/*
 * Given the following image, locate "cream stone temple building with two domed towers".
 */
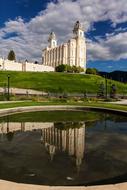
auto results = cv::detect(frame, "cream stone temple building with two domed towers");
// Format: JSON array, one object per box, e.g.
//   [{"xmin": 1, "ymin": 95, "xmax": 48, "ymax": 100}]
[{"xmin": 42, "ymin": 21, "xmax": 86, "ymax": 70}]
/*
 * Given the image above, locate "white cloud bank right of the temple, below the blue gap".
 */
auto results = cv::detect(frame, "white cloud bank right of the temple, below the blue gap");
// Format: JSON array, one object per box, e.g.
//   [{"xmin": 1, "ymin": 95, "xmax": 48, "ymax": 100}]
[{"xmin": 87, "ymin": 32, "xmax": 127, "ymax": 60}]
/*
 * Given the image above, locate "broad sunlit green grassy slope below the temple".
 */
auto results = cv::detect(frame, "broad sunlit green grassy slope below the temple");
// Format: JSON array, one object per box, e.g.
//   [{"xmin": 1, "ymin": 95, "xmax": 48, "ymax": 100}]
[{"xmin": 0, "ymin": 71, "xmax": 127, "ymax": 94}]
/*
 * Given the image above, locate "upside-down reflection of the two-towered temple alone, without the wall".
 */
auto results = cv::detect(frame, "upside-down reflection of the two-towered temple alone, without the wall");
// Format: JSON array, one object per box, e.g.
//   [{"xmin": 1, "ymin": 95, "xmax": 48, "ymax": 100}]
[{"xmin": 41, "ymin": 122, "xmax": 85, "ymax": 169}]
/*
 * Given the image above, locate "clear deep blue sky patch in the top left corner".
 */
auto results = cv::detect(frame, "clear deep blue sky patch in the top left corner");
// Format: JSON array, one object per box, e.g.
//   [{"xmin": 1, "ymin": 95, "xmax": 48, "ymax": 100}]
[{"xmin": 0, "ymin": 0, "xmax": 50, "ymax": 26}]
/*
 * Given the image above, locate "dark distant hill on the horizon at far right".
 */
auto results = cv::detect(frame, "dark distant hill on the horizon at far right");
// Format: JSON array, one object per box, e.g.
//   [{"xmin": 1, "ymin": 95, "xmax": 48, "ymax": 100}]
[{"xmin": 99, "ymin": 71, "xmax": 127, "ymax": 82}]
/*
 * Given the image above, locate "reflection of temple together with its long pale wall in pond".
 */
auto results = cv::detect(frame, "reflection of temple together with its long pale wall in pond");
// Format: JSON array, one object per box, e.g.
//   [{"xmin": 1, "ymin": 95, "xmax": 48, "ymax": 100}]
[{"xmin": 0, "ymin": 121, "xmax": 85, "ymax": 170}]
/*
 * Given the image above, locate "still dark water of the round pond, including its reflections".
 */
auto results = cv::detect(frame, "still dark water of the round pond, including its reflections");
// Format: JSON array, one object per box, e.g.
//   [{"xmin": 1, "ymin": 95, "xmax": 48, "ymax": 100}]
[{"xmin": 0, "ymin": 111, "xmax": 127, "ymax": 185}]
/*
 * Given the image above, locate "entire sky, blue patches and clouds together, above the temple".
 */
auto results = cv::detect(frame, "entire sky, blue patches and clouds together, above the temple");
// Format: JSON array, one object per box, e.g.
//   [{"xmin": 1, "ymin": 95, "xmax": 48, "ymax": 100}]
[{"xmin": 0, "ymin": 0, "xmax": 127, "ymax": 71}]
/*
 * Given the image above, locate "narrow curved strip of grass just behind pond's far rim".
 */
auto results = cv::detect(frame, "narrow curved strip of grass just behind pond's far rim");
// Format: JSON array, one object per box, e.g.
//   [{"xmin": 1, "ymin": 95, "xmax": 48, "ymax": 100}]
[{"xmin": 0, "ymin": 101, "xmax": 127, "ymax": 111}]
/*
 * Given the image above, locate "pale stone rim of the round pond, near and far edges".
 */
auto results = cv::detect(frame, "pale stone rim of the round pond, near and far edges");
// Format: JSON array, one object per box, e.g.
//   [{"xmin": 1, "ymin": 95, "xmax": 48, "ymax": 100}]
[{"xmin": 0, "ymin": 105, "xmax": 127, "ymax": 190}]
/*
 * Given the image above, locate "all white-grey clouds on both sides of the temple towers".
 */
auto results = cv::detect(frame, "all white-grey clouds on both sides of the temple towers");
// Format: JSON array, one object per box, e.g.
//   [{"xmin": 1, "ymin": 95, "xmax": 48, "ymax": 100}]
[{"xmin": 0, "ymin": 0, "xmax": 127, "ymax": 61}]
